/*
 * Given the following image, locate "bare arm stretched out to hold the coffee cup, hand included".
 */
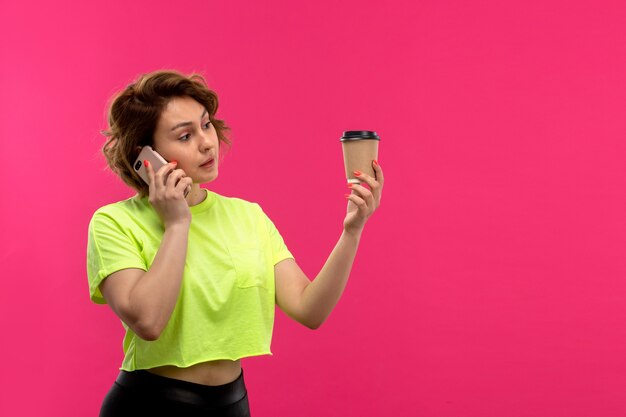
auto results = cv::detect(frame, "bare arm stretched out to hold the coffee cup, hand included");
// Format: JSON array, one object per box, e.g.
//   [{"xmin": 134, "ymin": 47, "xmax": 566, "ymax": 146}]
[{"xmin": 274, "ymin": 161, "xmax": 385, "ymax": 329}]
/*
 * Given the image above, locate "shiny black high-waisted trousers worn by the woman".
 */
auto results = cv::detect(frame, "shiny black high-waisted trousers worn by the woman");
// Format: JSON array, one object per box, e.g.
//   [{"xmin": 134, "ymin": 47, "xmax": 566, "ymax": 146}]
[{"xmin": 100, "ymin": 370, "xmax": 250, "ymax": 417}]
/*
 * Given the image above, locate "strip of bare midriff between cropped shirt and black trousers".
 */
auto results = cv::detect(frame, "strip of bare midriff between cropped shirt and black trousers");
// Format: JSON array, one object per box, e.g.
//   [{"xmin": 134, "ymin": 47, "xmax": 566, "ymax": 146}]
[{"xmin": 148, "ymin": 360, "xmax": 241, "ymax": 386}]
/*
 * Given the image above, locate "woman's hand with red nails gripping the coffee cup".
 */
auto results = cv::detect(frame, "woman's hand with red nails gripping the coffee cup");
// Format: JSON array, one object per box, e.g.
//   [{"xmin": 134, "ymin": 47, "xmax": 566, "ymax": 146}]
[{"xmin": 343, "ymin": 161, "xmax": 385, "ymax": 234}]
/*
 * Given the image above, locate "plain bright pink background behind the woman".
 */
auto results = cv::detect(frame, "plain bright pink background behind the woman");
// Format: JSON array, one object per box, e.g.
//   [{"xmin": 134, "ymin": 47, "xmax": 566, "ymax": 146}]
[{"xmin": 0, "ymin": 0, "xmax": 626, "ymax": 417}]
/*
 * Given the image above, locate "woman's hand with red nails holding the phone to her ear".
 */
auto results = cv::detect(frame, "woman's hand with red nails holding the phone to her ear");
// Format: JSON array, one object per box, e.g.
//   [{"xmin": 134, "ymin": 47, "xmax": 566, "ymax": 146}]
[{"xmin": 144, "ymin": 161, "xmax": 193, "ymax": 229}]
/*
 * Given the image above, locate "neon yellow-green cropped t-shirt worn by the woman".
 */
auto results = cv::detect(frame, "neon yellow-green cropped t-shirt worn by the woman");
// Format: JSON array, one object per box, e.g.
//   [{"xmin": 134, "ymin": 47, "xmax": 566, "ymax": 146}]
[{"xmin": 87, "ymin": 190, "xmax": 293, "ymax": 371}]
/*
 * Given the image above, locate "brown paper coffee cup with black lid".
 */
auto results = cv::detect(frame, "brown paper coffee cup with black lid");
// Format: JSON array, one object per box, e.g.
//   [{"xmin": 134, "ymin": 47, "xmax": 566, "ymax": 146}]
[{"xmin": 340, "ymin": 130, "xmax": 380, "ymax": 184}]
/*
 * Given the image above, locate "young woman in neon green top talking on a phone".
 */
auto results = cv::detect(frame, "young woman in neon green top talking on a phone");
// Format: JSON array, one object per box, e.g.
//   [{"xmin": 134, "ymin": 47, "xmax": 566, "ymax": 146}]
[{"xmin": 87, "ymin": 71, "xmax": 383, "ymax": 417}]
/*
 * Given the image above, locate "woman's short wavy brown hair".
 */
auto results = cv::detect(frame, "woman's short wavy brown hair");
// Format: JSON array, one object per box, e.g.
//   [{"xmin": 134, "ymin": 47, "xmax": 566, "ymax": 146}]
[{"xmin": 102, "ymin": 71, "xmax": 230, "ymax": 196}]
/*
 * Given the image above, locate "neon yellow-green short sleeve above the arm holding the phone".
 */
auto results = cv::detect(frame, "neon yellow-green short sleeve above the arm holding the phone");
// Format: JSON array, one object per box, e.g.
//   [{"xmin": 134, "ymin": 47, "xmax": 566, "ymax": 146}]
[{"xmin": 87, "ymin": 212, "xmax": 147, "ymax": 304}]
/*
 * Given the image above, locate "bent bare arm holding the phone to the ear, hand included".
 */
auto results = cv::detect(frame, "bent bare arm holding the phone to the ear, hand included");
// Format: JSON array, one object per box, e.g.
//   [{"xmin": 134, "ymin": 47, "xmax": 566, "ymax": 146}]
[{"xmin": 100, "ymin": 163, "xmax": 192, "ymax": 340}]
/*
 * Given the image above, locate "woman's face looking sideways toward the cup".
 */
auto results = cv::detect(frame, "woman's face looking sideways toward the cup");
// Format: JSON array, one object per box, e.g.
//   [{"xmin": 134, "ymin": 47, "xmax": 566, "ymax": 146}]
[{"xmin": 153, "ymin": 97, "xmax": 219, "ymax": 183}]
